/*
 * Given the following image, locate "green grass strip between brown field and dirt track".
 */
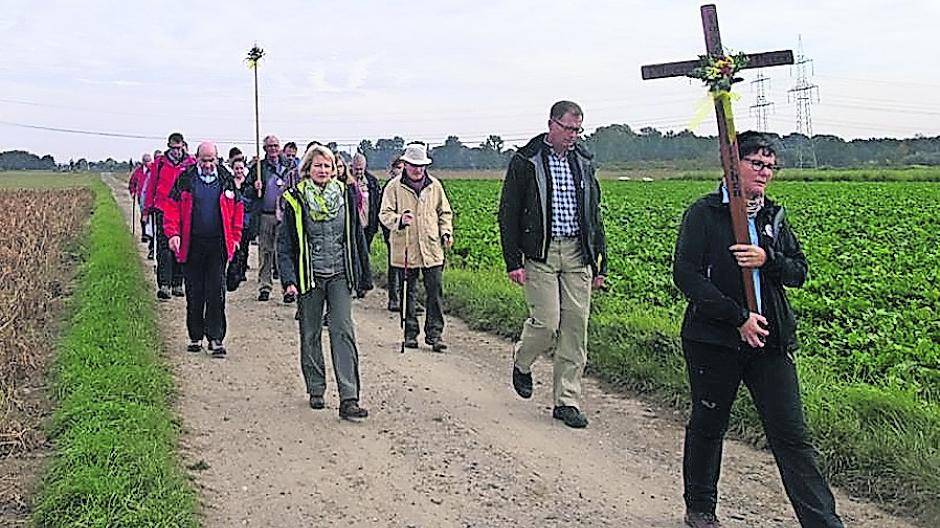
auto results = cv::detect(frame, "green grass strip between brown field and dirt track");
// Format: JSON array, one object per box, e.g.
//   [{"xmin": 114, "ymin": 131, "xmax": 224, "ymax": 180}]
[{"xmin": 32, "ymin": 181, "xmax": 197, "ymax": 527}]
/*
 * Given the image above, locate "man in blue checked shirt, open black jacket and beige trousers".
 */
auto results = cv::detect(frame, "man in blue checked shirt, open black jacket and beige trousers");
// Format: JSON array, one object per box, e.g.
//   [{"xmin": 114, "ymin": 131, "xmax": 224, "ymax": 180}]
[{"xmin": 499, "ymin": 101, "xmax": 607, "ymax": 428}]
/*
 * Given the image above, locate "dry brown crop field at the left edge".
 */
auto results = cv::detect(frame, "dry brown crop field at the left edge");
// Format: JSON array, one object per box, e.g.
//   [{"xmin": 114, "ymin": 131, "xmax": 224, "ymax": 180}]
[{"xmin": 0, "ymin": 189, "xmax": 93, "ymax": 524}]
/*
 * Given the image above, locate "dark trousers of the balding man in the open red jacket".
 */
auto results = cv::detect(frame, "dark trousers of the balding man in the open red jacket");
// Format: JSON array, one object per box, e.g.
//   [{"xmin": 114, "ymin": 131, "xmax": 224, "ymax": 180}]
[{"xmin": 185, "ymin": 237, "xmax": 226, "ymax": 341}]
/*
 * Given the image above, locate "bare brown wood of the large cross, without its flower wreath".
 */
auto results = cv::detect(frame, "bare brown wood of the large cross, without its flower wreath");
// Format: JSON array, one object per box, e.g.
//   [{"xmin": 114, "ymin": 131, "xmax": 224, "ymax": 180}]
[{"xmin": 640, "ymin": 4, "xmax": 793, "ymax": 312}]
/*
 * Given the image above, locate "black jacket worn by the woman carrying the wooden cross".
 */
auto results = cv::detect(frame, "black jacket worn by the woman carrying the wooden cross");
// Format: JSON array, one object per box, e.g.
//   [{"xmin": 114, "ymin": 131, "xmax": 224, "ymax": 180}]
[{"xmin": 673, "ymin": 191, "xmax": 808, "ymax": 352}]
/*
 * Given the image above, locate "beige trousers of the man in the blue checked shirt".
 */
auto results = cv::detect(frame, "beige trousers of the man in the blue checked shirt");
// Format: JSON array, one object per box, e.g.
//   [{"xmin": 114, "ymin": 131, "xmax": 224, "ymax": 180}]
[{"xmin": 515, "ymin": 238, "xmax": 592, "ymax": 408}]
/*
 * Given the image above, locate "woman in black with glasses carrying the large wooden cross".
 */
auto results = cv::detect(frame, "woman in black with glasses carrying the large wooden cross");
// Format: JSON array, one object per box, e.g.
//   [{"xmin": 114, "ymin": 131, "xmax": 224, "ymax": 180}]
[{"xmin": 673, "ymin": 132, "xmax": 842, "ymax": 528}]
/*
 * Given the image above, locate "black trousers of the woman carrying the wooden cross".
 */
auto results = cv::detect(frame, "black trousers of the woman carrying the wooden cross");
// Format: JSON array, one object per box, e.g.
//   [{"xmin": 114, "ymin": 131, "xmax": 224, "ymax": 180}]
[{"xmin": 682, "ymin": 339, "xmax": 843, "ymax": 528}]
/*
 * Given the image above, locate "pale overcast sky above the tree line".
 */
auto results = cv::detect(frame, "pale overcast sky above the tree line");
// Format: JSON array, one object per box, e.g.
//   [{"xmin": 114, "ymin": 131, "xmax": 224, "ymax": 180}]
[{"xmin": 0, "ymin": 0, "xmax": 940, "ymax": 162}]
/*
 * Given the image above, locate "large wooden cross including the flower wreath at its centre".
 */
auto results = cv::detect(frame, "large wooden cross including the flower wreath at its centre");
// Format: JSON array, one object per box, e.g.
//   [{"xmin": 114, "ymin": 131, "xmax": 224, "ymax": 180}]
[{"xmin": 641, "ymin": 4, "xmax": 793, "ymax": 312}]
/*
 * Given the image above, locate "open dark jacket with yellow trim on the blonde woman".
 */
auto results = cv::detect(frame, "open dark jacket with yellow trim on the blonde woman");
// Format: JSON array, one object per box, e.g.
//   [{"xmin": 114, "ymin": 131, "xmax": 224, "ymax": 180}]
[{"xmin": 277, "ymin": 185, "xmax": 372, "ymax": 294}]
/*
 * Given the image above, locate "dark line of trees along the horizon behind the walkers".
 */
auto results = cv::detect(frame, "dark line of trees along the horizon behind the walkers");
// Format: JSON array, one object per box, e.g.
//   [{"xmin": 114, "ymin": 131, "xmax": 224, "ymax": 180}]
[{"xmin": 7, "ymin": 125, "xmax": 940, "ymax": 172}]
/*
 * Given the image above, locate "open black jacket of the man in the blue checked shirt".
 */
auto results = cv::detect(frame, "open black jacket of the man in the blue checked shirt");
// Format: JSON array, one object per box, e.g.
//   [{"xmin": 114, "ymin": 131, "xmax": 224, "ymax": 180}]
[{"xmin": 499, "ymin": 134, "xmax": 607, "ymax": 276}]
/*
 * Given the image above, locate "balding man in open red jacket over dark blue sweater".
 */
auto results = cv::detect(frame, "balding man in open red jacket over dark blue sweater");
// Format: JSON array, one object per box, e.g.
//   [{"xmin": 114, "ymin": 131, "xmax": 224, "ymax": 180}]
[{"xmin": 163, "ymin": 142, "xmax": 245, "ymax": 357}]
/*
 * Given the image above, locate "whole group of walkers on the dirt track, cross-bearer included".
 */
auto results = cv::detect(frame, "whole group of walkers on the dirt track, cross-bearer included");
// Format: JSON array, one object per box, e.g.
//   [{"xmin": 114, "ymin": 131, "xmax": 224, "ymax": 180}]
[{"xmin": 129, "ymin": 101, "xmax": 842, "ymax": 528}]
